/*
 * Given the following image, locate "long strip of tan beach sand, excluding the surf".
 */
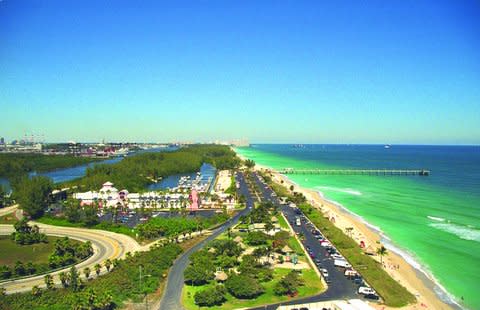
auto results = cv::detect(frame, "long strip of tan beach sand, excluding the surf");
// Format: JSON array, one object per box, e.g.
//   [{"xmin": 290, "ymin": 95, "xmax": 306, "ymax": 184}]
[{"xmin": 234, "ymin": 150, "xmax": 454, "ymax": 309}]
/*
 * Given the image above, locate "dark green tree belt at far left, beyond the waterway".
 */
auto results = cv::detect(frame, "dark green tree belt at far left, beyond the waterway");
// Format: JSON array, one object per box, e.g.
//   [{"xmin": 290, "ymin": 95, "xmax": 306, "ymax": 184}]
[{"xmin": 0, "ymin": 153, "xmax": 99, "ymax": 179}]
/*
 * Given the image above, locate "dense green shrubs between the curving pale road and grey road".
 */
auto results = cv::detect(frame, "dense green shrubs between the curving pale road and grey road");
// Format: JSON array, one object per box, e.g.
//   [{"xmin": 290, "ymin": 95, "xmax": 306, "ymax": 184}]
[{"xmin": 0, "ymin": 244, "xmax": 182, "ymax": 310}]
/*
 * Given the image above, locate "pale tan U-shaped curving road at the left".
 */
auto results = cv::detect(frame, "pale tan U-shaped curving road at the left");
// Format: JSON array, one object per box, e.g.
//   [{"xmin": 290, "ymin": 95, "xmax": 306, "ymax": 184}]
[{"xmin": 0, "ymin": 223, "xmax": 142, "ymax": 293}]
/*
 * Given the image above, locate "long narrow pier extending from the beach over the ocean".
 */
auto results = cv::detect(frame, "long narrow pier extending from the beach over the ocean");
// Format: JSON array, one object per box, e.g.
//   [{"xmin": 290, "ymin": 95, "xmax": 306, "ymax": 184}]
[{"xmin": 278, "ymin": 168, "xmax": 430, "ymax": 176}]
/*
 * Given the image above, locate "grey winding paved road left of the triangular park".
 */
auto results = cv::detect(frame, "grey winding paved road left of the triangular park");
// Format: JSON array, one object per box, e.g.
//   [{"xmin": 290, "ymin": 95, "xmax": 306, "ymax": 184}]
[{"xmin": 160, "ymin": 172, "xmax": 254, "ymax": 310}]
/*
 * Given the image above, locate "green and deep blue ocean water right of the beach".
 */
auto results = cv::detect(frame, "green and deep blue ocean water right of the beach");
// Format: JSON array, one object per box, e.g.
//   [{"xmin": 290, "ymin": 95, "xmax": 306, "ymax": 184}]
[{"xmin": 236, "ymin": 144, "xmax": 480, "ymax": 309}]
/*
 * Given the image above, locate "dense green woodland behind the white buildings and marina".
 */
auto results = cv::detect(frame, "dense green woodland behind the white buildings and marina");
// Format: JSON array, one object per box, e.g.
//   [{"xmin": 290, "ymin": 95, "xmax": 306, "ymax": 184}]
[{"xmin": 67, "ymin": 145, "xmax": 240, "ymax": 192}]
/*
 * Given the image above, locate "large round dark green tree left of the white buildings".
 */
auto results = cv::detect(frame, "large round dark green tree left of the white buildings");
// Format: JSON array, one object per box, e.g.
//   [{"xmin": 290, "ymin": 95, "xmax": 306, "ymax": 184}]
[{"xmin": 13, "ymin": 176, "xmax": 53, "ymax": 218}]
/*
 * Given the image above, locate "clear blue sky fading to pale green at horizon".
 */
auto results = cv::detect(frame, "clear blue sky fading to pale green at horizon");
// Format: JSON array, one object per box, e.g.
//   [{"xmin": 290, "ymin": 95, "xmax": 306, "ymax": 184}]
[{"xmin": 0, "ymin": 0, "xmax": 480, "ymax": 144}]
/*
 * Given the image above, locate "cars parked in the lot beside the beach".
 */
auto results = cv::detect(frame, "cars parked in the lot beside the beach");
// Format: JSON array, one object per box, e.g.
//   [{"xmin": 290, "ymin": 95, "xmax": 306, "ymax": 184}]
[{"xmin": 297, "ymin": 211, "xmax": 379, "ymax": 300}]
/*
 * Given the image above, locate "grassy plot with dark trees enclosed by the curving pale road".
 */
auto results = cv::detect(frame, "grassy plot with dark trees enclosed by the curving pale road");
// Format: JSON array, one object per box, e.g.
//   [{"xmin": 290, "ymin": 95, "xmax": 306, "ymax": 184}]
[{"xmin": 0, "ymin": 236, "xmax": 86, "ymax": 280}]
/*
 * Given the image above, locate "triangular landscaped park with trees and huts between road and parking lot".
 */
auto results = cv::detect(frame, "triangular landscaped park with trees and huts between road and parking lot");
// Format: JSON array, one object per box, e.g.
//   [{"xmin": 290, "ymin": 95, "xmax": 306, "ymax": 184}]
[{"xmin": 182, "ymin": 203, "xmax": 325, "ymax": 310}]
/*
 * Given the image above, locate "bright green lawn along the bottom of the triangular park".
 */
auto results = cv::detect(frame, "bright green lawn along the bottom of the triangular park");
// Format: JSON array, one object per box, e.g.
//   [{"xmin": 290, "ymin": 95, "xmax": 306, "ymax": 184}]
[{"xmin": 182, "ymin": 268, "xmax": 324, "ymax": 310}]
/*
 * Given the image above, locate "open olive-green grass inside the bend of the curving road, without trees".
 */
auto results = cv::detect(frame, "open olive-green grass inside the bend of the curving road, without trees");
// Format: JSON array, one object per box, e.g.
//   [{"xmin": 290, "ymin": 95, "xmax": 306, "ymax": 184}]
[{"xmin": 0, "ymin": 236, "xmax": 80, "ymax": 267}]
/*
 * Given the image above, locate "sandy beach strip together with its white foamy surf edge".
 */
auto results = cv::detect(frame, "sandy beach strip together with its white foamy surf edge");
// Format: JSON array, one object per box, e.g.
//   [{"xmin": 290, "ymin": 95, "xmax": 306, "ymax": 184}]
[{"xmin": 237, "ymin": 153, "xmax": 462, "ymax": 309}]
